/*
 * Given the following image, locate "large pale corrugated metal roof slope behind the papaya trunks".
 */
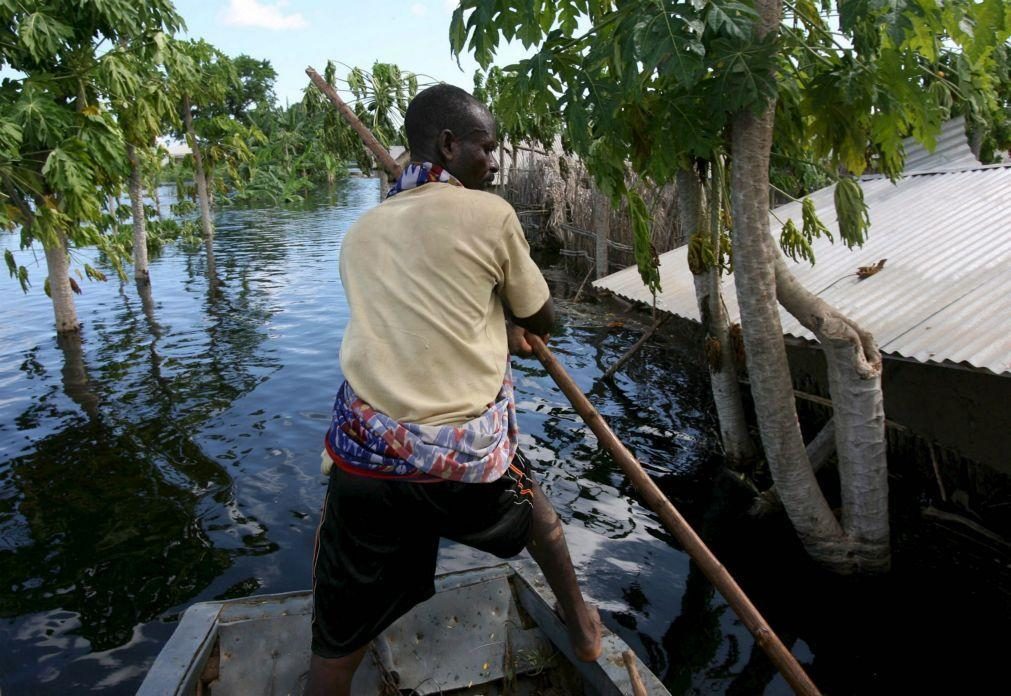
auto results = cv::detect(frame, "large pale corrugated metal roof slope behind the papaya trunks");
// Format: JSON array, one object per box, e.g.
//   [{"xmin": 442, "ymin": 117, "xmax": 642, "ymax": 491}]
[{"xmin": 593, "ymin": 164, "xmax": 1011, "ymax": 374}]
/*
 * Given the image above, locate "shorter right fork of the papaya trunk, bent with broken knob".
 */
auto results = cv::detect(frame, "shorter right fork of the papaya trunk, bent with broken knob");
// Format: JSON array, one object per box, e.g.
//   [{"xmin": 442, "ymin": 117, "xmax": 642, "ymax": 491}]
[{"xmin": 775, "ymin": 253, "xmax": 891, "ymax": 572}]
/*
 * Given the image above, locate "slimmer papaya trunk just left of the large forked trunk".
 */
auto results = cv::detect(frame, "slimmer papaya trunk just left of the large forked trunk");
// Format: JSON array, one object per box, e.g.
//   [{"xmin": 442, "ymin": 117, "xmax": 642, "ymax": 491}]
[{"xmin": 676, "ymin": 169, "xmax": 755, "ymax": 466}]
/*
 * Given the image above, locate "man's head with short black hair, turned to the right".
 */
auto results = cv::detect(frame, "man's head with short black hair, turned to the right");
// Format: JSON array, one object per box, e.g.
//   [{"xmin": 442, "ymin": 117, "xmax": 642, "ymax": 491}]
[{"xmin": 403, "ymin": 85, "xmax": 498, "ymax": 189}]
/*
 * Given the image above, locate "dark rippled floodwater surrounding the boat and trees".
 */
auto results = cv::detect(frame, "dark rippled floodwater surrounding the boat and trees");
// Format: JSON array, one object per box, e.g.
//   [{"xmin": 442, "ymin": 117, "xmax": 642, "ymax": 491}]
[{"xmin": 0, "ymin": 179, "xmax": 1011, "ymax": 696}]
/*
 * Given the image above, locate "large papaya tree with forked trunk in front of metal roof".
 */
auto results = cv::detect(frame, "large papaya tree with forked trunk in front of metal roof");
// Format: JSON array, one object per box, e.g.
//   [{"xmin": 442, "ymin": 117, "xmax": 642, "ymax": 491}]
[{"xmin": 450, "ymin": 0, "xmax": 1011, "ymax": 573}]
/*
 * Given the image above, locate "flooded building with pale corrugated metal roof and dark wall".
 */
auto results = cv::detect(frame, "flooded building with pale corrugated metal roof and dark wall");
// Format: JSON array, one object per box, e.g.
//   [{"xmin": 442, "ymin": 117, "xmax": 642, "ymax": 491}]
[{"xmin": 594, "ymin": 119, "xmax": 1011, "ymax": 534}]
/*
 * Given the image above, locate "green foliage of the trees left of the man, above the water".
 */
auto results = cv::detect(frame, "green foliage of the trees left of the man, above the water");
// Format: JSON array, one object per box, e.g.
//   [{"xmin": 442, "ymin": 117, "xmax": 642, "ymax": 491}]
[{"xmin": 0, "ymin": 0, "xmax": 382, "ymax": 309}]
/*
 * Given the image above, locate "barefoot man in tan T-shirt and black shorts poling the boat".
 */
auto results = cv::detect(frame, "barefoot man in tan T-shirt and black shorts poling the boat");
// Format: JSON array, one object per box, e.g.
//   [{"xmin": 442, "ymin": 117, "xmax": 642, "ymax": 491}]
[{"xmin": 308, "ymin": 85, "xmax": 601, "ymax": 695}]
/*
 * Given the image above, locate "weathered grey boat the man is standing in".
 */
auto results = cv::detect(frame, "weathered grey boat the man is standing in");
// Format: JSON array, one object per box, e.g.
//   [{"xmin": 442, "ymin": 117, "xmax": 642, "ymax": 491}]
[{"xmin": 137, "ymin": 560, "xmax": 669, "ymax": 696}]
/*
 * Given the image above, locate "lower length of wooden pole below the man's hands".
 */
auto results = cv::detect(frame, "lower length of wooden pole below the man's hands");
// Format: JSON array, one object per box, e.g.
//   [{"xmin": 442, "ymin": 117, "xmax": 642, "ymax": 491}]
[{"xmin": 529, "ymin": 336, "xmax": 819, "ymax": 696}]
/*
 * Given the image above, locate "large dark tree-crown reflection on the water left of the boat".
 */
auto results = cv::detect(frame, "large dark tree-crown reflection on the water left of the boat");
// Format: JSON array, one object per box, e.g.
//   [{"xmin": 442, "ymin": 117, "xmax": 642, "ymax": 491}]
[{"xmin": 0, "ymin": 325, "xmax": 228, "ymax": 649}]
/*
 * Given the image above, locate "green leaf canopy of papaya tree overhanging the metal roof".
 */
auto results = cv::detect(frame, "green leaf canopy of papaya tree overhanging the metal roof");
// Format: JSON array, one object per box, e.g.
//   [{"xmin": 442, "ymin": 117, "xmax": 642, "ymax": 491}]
[{"xmin": 449, "ymin": 0, "xmax": 1011, "ymax": 285}]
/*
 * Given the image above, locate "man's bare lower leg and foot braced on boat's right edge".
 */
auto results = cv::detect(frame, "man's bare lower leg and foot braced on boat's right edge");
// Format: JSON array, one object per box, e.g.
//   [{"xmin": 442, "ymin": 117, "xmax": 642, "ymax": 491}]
[{"xmin": 527, "ymin": 484, "xmax": 601, "ymax": 662}]
